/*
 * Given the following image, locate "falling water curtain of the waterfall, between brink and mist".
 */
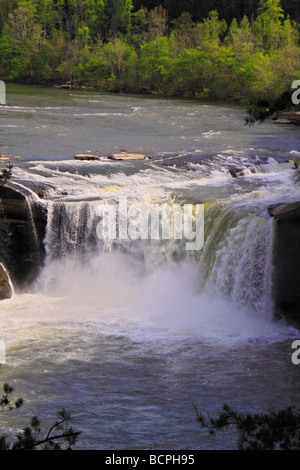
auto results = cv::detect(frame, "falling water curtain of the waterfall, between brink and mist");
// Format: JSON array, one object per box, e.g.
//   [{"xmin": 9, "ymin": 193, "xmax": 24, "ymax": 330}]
[{"xmin": 45, "ymin": 195, "xmax": 273, "ymax": 319}]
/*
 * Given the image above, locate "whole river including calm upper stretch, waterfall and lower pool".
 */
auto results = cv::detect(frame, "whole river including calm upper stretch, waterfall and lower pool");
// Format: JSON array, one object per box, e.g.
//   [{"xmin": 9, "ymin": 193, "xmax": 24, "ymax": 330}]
[{"xmin": 0, "ymin": 84, "xmax": 300, "ymax": 450}]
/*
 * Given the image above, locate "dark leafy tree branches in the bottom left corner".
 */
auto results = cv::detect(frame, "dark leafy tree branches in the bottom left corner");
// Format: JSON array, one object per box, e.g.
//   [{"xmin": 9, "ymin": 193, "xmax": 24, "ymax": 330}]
[{"xmin": 0, "ymin": 383, "xmax": 80, "ymax": 450}]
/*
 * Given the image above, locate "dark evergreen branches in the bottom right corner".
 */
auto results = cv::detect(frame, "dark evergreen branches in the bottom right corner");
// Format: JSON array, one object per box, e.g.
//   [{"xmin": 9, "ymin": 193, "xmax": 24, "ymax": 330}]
[{"xmin": 195, "ymin": 404, "xmax": 300, "ymax": 450}]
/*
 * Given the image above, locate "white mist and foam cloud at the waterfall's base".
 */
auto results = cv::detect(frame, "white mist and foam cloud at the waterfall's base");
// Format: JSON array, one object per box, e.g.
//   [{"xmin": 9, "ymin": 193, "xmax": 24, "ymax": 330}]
[{"xmin": 1, "ymin": 254, "xmax": 296, "ymax": 356}]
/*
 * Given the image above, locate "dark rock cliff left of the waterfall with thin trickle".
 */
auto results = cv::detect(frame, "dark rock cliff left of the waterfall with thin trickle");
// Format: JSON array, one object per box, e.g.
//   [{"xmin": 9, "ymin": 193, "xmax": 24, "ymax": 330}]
[{"xmin": 0, "ymin": 184, "xmax": 47, "ymax": 288}]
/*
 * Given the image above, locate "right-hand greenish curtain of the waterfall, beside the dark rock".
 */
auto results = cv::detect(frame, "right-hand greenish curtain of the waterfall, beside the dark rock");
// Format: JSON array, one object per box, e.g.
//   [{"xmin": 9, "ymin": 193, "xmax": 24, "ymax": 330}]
[{"xmin": 201, "ymin": 204, "xmax": 274, "ymax": 319}]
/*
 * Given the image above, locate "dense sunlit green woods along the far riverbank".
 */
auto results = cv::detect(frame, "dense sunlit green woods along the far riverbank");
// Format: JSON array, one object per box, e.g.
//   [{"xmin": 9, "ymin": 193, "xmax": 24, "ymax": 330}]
[{"xmin": 0, "ymin": 0, "xmax": 300, "ymax": 106}]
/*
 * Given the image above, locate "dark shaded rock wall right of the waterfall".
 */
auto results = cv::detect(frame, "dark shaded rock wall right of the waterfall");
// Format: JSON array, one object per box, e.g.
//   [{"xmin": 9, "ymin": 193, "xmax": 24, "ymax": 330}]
[{"xmin": 269, "ymin": 202, "xmax": 300, "ymax": 327}]
